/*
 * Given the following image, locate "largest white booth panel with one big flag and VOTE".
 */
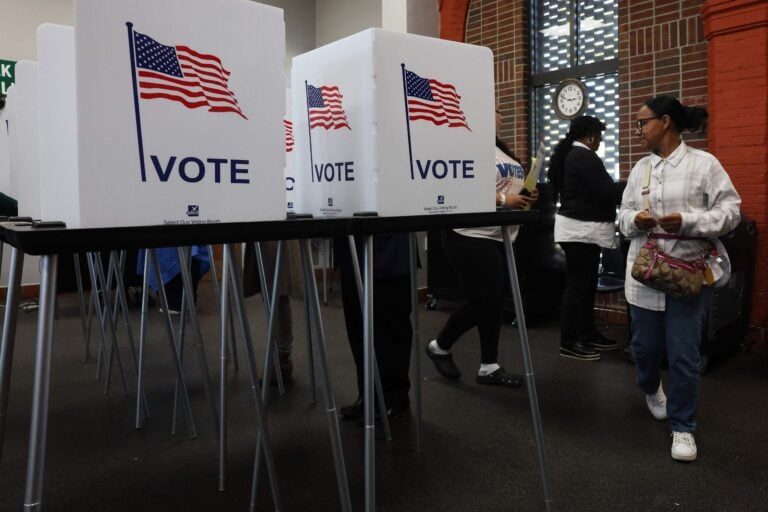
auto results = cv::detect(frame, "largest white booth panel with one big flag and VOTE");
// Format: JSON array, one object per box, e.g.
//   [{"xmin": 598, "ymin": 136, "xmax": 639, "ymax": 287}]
[{"xmin": 75, "ymin": 0, "xmax": 286, "ymax": 227}]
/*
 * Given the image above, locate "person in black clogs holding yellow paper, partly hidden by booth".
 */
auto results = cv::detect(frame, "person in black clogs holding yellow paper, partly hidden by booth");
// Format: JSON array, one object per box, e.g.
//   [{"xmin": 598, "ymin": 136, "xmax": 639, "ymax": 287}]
[{"xmin": 427, "ymin": 108, "xmax": 539, "ymax": 387}]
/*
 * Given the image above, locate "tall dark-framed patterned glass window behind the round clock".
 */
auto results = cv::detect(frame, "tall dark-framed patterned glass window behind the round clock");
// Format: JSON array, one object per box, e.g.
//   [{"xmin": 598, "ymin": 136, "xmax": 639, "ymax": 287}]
[{"xmin": 530, "ymin": 0, "xmax": 619, "ymax": 179}]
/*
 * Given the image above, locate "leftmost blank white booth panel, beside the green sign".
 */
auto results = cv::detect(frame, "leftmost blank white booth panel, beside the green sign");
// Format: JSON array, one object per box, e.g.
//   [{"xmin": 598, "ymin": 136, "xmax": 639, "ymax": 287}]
[{"xmin": 8, "ymin": 60, "xmax": 41, "ymax": 219}]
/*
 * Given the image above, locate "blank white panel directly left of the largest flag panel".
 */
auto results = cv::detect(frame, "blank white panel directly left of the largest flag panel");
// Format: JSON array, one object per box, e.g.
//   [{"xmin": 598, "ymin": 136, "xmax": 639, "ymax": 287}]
[{"xmin": 37, "ymin": 23, "xmax": 80, "ymax": 226}]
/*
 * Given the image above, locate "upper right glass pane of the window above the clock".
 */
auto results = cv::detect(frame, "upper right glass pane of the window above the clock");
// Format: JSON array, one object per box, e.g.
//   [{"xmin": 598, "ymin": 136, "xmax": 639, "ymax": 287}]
[{"xmin": 576, "ymin": 0, "xmax": 619, "ymax": 65}]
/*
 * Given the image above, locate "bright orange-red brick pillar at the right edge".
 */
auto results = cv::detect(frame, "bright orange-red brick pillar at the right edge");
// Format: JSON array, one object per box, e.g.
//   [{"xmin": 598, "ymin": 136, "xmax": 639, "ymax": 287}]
[{"xmin": 704, "ymin": 0, "xmax": 768, "ymax": 328}]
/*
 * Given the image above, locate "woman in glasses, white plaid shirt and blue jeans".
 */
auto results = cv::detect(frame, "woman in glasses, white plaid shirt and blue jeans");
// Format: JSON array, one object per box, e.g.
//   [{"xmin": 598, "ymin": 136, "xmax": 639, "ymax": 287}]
[{"xmin": 619, "ymin": 96, "xmax": 741, "ymax": 461}]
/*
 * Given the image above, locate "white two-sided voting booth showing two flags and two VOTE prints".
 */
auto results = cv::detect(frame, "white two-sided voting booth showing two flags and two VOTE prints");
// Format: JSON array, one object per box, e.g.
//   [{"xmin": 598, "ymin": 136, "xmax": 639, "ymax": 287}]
[{"xmin": 291, "ymin": 29, "xmax": 496, "ymax": 216}]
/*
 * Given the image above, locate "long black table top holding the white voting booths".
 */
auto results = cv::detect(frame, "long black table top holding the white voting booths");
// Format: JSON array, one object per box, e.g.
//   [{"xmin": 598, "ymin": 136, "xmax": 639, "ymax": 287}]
[{"xmin": 0, "ymin": 210, "xmax": 538, "ymax": 255}]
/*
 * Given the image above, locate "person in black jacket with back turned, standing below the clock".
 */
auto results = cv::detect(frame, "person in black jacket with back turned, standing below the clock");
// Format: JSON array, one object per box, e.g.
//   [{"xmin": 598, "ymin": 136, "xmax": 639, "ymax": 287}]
[{"xmin": 547, "ymin": 116, "xmax": 619, "ymax": 361}]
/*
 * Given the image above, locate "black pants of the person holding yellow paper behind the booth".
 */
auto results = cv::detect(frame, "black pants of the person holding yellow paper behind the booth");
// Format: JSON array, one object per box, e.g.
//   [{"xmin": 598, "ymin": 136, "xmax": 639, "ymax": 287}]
[{"xmin": 437, "ymin": 230, "xmax": 507, "ymax": 364}]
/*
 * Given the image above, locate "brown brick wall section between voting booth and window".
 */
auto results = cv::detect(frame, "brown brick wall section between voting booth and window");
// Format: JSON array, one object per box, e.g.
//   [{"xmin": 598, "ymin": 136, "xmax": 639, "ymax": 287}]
[{"xmin": 465, "ymin": 0, "xmax": 529, "ymax": 164}]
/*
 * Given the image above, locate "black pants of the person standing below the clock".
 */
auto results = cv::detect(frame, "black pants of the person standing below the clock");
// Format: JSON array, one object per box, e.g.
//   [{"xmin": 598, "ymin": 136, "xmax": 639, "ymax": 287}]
[{"xmin": 560, "ymin": 242, "xmax": 600, "ymax": 345}]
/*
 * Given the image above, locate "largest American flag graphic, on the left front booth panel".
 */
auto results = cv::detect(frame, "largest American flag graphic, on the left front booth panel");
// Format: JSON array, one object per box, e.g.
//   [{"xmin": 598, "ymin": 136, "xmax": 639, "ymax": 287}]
[{"xmin": 133, "ymin": 31, "xmax": 248, "ymax": 119}]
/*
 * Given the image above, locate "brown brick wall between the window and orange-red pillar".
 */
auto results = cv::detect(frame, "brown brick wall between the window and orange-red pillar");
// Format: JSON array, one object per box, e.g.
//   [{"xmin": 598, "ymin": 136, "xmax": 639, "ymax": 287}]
[{"xmin": 619, "ymin": 0, "xmax": 707, "ymax": 178}]
